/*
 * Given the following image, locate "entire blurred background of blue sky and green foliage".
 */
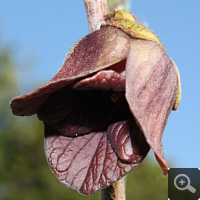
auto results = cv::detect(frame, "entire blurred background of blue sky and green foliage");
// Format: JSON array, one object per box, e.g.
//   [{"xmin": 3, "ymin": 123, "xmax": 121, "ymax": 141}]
[{"xmin": 0, "ymin": 0, "xmax": 200, "ymax": 200}]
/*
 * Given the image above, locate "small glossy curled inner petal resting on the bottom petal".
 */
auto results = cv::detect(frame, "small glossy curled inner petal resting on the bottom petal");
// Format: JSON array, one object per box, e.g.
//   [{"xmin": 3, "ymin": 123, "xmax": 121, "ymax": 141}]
[{"xmin": 107, "ymin": 120, "xmax": 149, "ymax": 163}]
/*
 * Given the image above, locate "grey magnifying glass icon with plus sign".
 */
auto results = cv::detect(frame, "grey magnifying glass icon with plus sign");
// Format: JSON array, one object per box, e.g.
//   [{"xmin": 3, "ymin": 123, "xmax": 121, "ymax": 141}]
[{"xmin": 174, "ymin": 174, "xmax": 196, "ymax": 193}]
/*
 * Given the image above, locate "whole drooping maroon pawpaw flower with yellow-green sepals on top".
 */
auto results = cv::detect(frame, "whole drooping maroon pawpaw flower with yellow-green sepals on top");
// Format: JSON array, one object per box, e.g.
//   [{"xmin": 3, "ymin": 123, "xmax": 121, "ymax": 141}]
[{"xmin": 11, "ymin": 11, "xmax": 180, "ymax": 195}]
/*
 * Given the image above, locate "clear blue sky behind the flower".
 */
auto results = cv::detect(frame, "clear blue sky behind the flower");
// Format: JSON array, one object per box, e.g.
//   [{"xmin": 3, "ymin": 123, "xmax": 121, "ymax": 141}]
[{"xmin": 0, "ymin": 0, "xmax": 200, "ymax": 168}]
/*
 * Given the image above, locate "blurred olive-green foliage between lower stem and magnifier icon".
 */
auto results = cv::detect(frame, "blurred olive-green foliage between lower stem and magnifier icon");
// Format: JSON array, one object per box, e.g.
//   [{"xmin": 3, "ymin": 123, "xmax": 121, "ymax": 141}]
[{"xmin": 126, "ymin": 158, "xmax": 168, "ymax": 200}]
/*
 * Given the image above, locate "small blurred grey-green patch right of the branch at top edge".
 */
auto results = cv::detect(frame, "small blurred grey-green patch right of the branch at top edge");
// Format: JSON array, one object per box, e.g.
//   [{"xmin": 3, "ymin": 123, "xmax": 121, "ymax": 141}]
[{"xmin": 107, "ymin": 0, "xmax": 131, "ymax": 11}]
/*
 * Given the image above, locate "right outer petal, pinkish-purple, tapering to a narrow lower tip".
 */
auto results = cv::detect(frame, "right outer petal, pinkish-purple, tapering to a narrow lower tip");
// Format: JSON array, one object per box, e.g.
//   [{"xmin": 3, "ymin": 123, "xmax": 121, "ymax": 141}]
[{"xmin": 126, "ymin": 40, "xmax": 178, "ymax": 174}]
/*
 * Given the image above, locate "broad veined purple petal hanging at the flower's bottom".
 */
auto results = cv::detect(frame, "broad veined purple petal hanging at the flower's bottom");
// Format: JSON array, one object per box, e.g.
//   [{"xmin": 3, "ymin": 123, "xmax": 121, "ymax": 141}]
[{"xmin": 45, "ymin": 126, "xmax": 147, "ymax": 195}]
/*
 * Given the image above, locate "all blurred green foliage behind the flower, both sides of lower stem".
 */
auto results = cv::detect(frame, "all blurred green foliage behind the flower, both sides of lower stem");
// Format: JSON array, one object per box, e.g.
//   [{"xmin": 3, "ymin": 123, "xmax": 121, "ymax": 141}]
[{"xmin": 0, "ymin": 35, "xmax": 167, "ymax": 200}]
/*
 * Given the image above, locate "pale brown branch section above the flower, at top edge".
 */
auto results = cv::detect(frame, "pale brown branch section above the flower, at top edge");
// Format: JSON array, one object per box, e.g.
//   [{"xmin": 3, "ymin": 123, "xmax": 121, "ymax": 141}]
[{"xmin": 84, "ymin": 0, "xmax": 109, "ymax": 33}]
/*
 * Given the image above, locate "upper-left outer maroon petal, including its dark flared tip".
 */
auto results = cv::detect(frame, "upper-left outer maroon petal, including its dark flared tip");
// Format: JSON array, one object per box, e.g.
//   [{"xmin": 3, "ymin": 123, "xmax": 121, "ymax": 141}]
[{"xmin": 11, "ymin": 27, "xmax": 130, "ymax": 116}]
